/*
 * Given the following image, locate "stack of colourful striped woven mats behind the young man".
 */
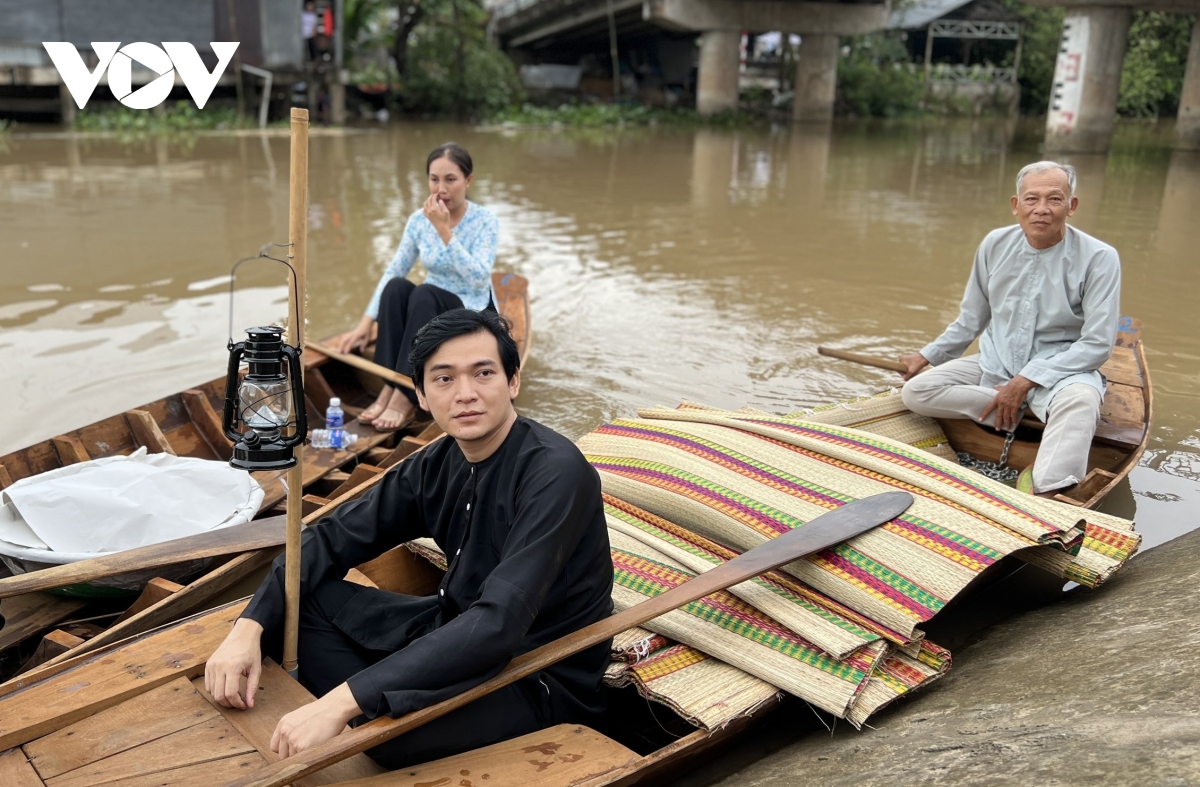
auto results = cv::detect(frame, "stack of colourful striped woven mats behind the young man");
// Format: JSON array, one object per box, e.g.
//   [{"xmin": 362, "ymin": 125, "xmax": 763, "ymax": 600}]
[{"xmin": 580, "ymin": 395, "xmax": 1140, "ymax": 729}]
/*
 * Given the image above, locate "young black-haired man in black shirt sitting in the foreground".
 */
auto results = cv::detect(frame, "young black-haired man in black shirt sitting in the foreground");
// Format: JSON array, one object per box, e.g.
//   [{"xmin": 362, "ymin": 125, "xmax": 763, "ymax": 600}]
[{"xmin": 205, "ymin": 310, "xmax": 612, "ymax": 768}]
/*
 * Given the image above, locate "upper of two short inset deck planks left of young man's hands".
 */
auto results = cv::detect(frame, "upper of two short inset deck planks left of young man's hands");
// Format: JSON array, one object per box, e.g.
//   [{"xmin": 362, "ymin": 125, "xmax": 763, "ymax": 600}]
[{"xmin": 23, "ymin": 678, "xmax": 221, "ymax": 779}]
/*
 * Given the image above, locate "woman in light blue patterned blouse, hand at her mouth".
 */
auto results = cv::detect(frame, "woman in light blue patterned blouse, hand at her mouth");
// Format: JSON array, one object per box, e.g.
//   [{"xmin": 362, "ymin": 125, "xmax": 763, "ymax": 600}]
[{"xmin": 337, "ymin": 142, "xmax": 499, "ymax": 432}]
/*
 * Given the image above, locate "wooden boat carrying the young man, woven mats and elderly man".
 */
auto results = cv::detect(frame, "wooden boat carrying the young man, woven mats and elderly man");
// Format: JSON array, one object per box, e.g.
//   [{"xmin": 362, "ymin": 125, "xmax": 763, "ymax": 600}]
[{"xmin": 0, "ymin": 320, "xmax": 1151, "ymax": 787}]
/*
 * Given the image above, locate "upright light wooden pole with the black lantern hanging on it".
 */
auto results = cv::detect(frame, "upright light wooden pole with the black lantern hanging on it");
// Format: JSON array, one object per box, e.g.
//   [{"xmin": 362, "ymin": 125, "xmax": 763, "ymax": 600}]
[{"xmin": 283, "ymin": 107, "xmax": 308, "ymax": 673}]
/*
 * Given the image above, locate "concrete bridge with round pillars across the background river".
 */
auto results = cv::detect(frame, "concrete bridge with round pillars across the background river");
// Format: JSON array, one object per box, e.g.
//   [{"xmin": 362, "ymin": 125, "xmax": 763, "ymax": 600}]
[{"xmin": 493, "ymin": 0, "xmax": 1200, "ymax": 154}]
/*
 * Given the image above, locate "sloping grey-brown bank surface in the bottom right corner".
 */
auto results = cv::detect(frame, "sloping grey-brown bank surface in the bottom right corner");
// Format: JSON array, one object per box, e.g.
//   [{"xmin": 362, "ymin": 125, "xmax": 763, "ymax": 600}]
[{"xmin": 688, "ymin": 531, "xmax": 1200, "ymax": 787}]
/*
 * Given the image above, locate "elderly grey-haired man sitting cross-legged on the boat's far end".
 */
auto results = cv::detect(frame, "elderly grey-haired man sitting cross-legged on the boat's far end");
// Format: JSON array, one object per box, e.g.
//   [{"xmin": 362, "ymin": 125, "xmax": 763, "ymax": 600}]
[{"xmin": 900, "ymin": 161, "xmax": 1121, "ymax": 494}]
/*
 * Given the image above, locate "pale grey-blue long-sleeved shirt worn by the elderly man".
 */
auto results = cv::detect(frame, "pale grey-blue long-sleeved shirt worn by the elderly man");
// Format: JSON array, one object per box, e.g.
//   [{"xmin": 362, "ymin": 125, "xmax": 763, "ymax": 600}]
[{"xmin": 920, "ymin": 224, "xmax": 1121, "ymax": 421}]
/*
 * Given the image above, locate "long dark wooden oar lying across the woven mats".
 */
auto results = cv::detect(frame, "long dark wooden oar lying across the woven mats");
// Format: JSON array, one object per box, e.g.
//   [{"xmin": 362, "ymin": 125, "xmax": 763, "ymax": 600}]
[{"xmin": 228, "ymin": 492, "xmax": 912, "ymax": 787}]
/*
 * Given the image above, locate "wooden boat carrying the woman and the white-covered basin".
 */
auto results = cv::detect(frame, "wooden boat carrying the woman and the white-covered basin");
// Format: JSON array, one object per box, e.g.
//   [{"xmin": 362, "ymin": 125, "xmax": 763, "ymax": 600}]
[{"xmin": 0, "ymin": 272, "xmax": 532, "ymax": 674}]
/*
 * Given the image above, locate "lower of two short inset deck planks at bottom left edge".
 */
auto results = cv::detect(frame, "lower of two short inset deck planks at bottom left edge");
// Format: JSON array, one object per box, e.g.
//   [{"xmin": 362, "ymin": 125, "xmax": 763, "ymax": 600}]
[{"xmin": 46, "ymin": 715, "xmax": 254, "ymax": 787}]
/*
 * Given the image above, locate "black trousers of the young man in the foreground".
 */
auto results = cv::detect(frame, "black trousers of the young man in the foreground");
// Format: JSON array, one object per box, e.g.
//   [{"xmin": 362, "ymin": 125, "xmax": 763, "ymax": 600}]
[{"xmin": 272, "ymin": 579, "xmax": 548, "ymax": 769}]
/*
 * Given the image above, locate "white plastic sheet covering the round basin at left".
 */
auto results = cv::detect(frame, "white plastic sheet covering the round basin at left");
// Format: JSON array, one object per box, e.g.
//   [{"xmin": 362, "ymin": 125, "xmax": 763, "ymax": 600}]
[{"xmin": 0, "ymin": 449, "xmax": 263, "ymax": 563}]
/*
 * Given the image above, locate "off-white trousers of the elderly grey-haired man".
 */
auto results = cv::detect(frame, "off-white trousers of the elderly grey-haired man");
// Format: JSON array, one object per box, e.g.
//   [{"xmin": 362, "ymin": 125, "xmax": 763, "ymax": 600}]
[{"xmin": 901, "ymin": 355, "xmax": 1102, "ymax": 492}]
